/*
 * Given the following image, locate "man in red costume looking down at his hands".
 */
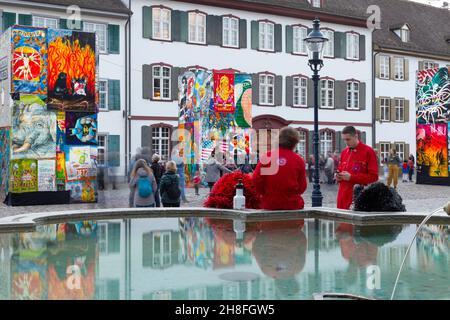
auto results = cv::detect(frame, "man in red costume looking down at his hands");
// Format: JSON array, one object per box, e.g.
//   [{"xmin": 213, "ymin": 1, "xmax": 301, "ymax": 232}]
[{"xmin": 336, "ymin": 126, "xmax": 378, "ymax": 210}]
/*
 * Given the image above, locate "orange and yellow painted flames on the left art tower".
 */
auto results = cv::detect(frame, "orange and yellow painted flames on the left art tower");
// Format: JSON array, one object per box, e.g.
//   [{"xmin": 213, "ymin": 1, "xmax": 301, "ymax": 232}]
[{"xmin": 48, "ymin": 38, "xmax": 96, "ymax": 94}]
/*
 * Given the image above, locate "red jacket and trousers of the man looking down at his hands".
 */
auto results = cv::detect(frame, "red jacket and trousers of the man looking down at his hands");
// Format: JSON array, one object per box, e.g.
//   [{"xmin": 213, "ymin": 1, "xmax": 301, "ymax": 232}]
[{"xmin": 337, "ymin": 142, "xmax": 378, "ymax": 210}]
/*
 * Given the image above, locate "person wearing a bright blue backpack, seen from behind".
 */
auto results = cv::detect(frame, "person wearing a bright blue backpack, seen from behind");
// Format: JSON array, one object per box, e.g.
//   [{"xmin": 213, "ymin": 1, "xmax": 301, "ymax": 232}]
[{"xmin": 130, "ymin": 159, "xmax": 157, "ymax": 208}]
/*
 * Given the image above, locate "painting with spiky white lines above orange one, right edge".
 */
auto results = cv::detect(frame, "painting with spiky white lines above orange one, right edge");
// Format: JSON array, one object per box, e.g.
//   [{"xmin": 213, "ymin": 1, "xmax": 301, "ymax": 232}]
[{"xmin": 416, "ymin": 68, "xmax": 450, "ymax": 124}]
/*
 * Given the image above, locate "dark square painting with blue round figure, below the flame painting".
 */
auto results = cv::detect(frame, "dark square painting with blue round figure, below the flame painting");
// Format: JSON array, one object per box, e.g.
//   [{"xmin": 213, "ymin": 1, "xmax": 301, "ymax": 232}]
[{"xmin": 66, "ymin": 112, "xmax": 97, "ymax": 145}]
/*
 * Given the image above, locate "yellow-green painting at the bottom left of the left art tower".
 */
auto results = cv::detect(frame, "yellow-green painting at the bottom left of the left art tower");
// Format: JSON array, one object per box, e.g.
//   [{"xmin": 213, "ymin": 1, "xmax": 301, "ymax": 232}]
[{"xmin": 10, "ymin": 159, "xmax": 38, "ymax": 193}]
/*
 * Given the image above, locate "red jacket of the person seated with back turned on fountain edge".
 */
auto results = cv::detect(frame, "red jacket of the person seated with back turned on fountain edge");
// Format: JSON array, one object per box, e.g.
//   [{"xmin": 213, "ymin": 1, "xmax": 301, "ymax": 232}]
[{"xmin": 253, "ymin": 148, "xmax": 306, "ymax": 210}]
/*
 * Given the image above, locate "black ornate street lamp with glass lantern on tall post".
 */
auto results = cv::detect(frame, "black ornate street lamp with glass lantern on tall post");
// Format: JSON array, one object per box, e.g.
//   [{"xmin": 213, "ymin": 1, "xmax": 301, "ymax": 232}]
[{"xmin": 304, "ymin": 18, "xmax": 328, "ymax": 207}]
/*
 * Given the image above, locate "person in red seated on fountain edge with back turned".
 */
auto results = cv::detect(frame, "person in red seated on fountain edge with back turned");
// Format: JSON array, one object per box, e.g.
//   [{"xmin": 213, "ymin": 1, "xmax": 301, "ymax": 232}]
[{"xmin": 253, "ymin": 127, "xmax": 306, "ymax": 210}]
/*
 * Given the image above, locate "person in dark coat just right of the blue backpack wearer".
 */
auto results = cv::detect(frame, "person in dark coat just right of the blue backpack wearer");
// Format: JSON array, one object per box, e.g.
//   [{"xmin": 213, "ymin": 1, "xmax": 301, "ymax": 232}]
[{"xmin": 159, "ymin": 161, "xmax": 181, "ymax": 207}]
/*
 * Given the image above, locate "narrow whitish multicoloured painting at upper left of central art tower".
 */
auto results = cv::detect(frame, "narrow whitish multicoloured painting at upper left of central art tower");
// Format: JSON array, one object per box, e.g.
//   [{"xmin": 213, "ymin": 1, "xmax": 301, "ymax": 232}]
[{"xmin": 178, "ymin": 71, "xmax": 196, "ymax": 123}]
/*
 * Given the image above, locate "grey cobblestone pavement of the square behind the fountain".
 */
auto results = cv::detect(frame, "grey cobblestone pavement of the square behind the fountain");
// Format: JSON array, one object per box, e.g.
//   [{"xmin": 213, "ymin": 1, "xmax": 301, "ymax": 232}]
[{"xmin": 0, "ymin": 178, "xmax": 450, "ymax": 217}]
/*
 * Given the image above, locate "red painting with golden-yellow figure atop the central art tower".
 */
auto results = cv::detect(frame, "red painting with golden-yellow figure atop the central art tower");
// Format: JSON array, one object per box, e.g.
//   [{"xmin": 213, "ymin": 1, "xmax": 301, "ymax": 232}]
[{"xmin": 214, "ymin": 72, "xmax": 235, "ymax": 113}]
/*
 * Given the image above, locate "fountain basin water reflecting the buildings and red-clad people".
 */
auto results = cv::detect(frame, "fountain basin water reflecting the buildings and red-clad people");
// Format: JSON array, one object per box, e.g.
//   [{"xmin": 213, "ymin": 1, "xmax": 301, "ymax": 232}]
[{"xmin": 0, "ymin": 218, "xmax": 450, "ymax": 300}]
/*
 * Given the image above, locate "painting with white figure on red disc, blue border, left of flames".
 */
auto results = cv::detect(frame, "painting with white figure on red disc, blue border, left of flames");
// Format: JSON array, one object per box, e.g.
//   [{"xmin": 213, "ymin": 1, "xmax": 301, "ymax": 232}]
[{"xmin": 11, "ymin": 27, "xmax": 47, "ymax": 97}]
